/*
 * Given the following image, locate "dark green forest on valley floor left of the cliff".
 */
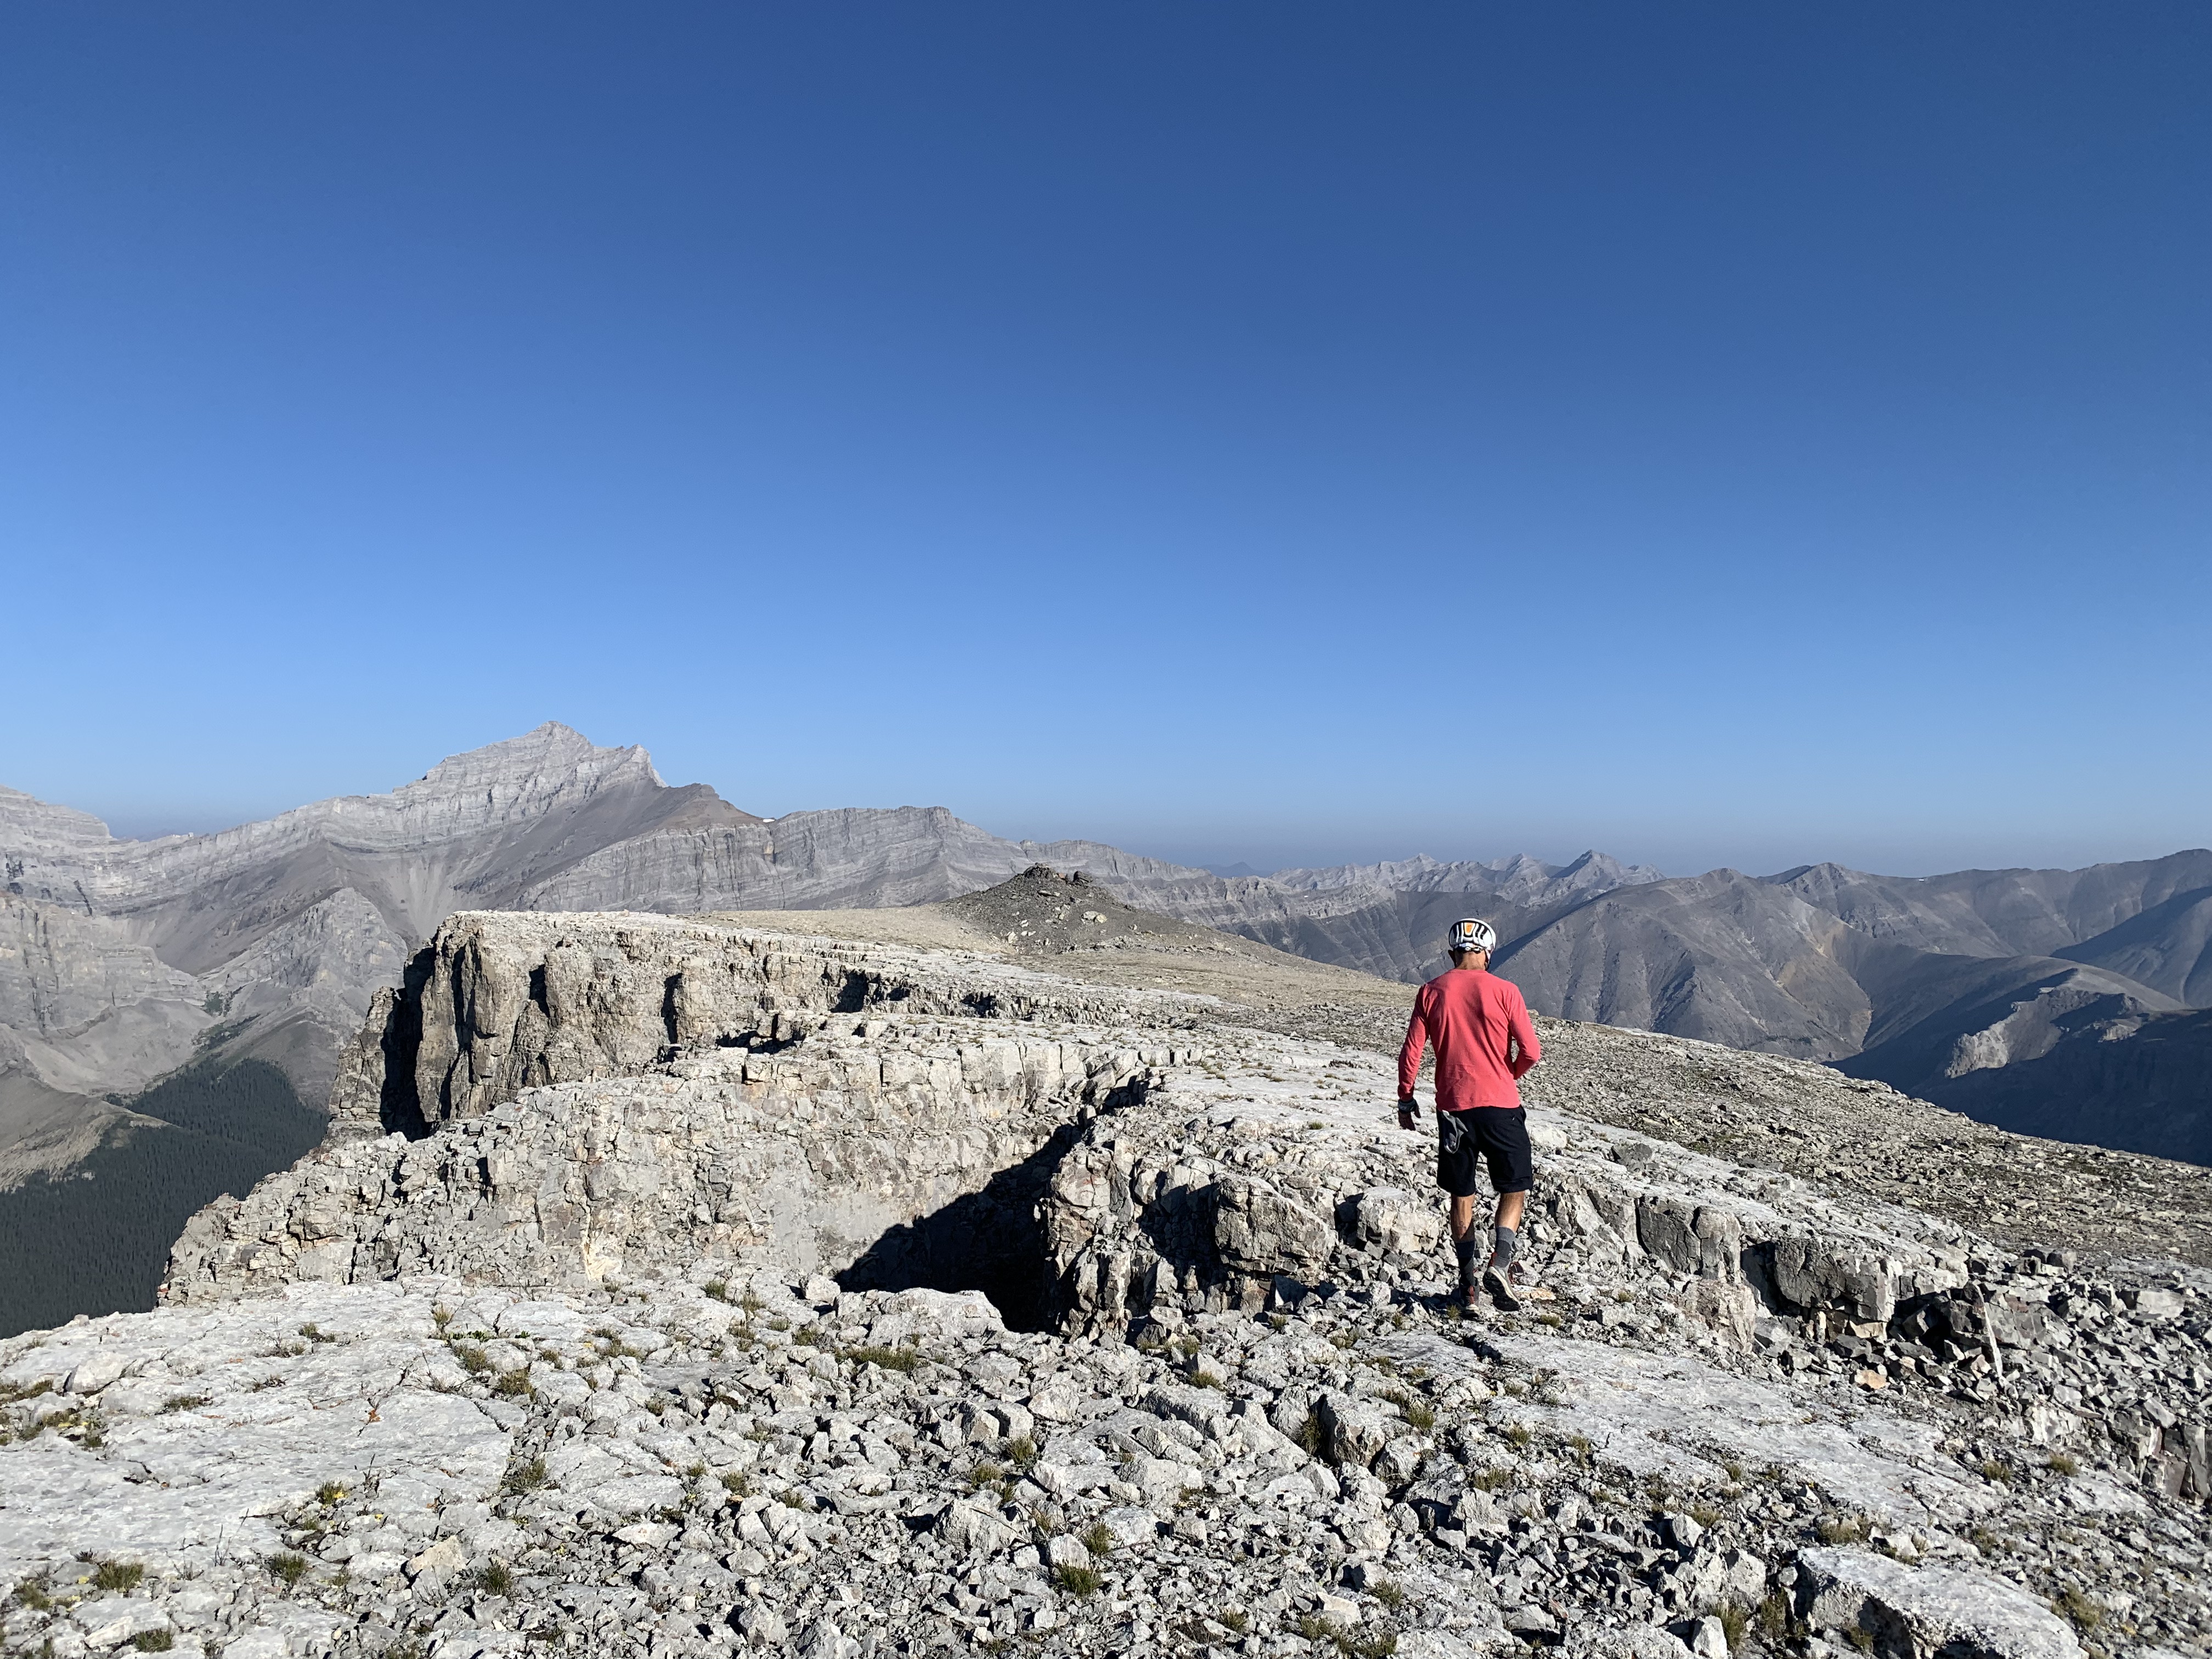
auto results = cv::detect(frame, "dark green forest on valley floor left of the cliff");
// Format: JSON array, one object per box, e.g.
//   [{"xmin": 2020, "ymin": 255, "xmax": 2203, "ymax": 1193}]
[{"xmin": 0, "ymin": 1059, "xmax": 328, "ymax": 1336}]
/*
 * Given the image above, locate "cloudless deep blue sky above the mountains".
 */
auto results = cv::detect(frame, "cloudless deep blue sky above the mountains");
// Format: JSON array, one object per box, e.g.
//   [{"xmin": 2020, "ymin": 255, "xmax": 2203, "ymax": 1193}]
[{"xmin": 0, "ymin": 0, "xmax": 2212, "ymax": 872}]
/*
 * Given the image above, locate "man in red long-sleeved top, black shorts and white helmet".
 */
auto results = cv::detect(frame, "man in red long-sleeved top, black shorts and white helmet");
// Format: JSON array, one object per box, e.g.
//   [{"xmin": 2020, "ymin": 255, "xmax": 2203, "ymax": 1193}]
[{"xmin": 1398, "ymin": 916, "xmax": 1544, "ymax": 1312}]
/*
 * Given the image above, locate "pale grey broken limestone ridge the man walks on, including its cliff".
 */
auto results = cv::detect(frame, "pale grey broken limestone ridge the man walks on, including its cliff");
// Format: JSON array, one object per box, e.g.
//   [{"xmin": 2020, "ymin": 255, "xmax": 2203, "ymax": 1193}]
[{"xmin": 0, "ymin": 913, "xmax": 2212, "ymax": 1659}]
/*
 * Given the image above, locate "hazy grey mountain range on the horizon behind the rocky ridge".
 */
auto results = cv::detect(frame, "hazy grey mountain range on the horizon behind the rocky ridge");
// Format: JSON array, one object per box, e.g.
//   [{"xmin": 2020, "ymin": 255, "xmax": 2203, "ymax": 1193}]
[{"xmin": 0, "ymin": 725, "xmax": 2212, "ymax": 1248}]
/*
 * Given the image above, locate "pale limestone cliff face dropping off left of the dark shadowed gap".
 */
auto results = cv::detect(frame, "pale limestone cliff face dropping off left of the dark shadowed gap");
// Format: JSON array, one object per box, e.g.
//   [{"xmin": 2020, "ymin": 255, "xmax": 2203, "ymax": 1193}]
[{"xmin": 170, "ymin": 911, "xmax": 1188, "ymax": 1301}]
